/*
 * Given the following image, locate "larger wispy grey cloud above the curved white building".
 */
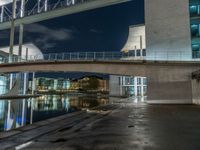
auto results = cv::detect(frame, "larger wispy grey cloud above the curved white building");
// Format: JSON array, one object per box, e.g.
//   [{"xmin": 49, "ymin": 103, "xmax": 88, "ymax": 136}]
[{"xmin": 25, "ymin": 24, "xmax": 75, "ymax": 49}]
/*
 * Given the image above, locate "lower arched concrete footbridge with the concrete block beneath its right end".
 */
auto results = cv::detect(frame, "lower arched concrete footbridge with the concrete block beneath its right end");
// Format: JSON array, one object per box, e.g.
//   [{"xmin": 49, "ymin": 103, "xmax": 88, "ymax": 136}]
[{"xmin": 0, "ymin": 61, "xmax": 200, "ymax": 104}]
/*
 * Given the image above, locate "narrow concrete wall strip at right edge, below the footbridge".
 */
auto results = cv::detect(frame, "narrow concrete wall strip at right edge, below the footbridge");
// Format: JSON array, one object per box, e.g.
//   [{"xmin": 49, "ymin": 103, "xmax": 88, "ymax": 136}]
[{"xmin": 192, "ymin": 80, "xmax": 200, "ymax": 104}]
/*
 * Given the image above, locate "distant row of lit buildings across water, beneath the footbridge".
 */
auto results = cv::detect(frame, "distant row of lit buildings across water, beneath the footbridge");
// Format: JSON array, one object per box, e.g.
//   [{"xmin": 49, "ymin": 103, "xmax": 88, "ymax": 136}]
[{"xmin": 29, "ymin": 76, "xmax": 108, "ymax": 92}]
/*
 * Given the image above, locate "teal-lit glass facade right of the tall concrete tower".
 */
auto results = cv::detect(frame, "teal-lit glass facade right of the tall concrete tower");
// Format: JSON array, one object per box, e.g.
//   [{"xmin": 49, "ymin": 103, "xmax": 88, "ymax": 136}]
[{"xmin": 189, "ymin": 0, "xmax": 200, "ymax": 58}]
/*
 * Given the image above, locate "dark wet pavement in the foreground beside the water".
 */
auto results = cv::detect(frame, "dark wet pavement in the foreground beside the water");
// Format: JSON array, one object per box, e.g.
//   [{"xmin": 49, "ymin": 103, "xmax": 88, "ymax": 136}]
[{"xmin": 0, "ymin": 100, "xmax": 200, "ymax": 150}]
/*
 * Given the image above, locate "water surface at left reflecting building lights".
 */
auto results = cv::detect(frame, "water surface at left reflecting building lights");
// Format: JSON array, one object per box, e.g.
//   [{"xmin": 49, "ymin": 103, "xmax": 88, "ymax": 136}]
[{"xmin": 0, "ymin": 95, "xmax": 109, "ymax": 132}]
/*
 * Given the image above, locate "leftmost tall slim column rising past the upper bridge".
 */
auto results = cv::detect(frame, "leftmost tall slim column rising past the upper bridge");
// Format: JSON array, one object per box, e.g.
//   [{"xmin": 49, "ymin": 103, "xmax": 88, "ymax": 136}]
[{"xmin": 9, "ymin": 0, "xmax": 16, "ymax": 62}]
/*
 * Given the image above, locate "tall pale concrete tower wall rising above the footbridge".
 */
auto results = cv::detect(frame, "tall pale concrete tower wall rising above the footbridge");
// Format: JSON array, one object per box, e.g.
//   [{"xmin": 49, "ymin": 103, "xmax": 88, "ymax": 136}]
[{"xmin": 145, "ymin": 0, "xmax": 192, "ymax": 60}]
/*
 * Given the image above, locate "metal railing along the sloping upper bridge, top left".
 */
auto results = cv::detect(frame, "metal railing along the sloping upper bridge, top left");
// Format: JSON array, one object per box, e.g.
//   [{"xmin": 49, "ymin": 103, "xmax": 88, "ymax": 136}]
[{"xmin": 0, "ymin": 0, "xmax": 94, "ymax": 24}]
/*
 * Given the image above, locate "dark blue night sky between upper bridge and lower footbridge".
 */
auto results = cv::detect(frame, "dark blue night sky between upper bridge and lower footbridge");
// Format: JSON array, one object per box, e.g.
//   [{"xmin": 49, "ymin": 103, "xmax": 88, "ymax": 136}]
[{"xmin": 0, "ymin": 0, "xmax": 144, "ymax": 78}]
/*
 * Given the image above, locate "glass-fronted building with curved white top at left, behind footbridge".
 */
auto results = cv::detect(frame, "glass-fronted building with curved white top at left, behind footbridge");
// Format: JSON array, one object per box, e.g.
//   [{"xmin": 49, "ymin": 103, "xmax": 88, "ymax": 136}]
[{"xmin": 0, "ymin": 43, "xmax": 43, "ymax": 94}]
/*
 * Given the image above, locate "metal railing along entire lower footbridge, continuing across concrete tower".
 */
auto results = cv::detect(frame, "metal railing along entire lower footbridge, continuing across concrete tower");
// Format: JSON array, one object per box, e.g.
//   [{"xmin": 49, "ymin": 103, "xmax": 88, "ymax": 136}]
[{"xmin": 0, "ymin": 50, "xmax": 200, "ymax": 64}]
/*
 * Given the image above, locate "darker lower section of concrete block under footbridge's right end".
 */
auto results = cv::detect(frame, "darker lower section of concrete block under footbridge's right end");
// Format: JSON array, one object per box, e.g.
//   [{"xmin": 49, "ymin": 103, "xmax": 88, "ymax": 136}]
[{"xmin": 147, "ymin": 79, "xmax": 192, "ymax": 104}]
